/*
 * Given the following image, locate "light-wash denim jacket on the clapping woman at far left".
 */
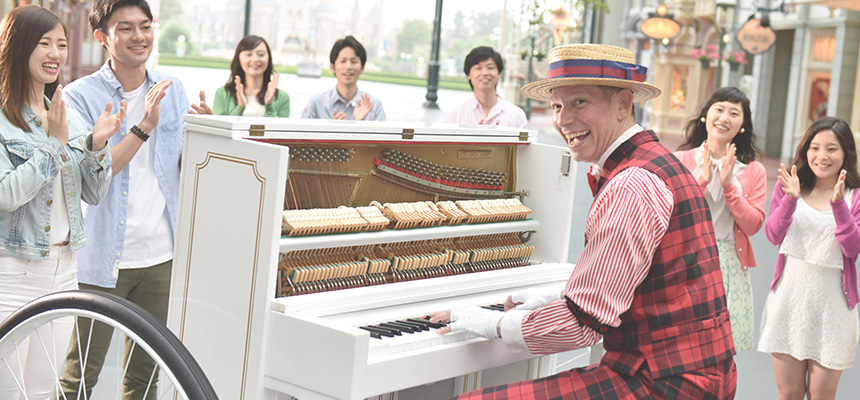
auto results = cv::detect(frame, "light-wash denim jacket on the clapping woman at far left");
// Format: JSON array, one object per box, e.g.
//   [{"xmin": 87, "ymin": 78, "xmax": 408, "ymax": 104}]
[{"xmin": 0, "ymin": 98, "xmax": 112, "ymax": 260}]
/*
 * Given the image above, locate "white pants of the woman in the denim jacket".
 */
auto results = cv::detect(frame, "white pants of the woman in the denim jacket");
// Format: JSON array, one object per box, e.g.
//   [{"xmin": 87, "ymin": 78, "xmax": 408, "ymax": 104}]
[{"xmin": 0, "ymin": 246, "xmax": 78, "ymax": 400}]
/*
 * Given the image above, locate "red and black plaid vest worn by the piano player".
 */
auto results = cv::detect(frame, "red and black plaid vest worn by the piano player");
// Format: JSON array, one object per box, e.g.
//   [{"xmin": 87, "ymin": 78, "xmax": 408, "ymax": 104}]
[{"xmin": 568, "ymin": 131, "xmax": 735, "ymax": 379}]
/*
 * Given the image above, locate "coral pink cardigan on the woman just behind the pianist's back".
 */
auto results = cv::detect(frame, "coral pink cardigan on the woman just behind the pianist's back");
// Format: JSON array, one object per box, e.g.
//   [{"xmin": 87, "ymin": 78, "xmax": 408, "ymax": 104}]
[{"xmin": 675, "ymin": 149, "xmax": 767, "ymax": 270}]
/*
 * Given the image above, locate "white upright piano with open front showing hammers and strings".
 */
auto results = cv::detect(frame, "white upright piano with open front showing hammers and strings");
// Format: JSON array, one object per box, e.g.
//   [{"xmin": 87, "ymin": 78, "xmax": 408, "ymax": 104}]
[{"xmin": 168, "ymin": 115, "xmax": 600, "ymax": 400}]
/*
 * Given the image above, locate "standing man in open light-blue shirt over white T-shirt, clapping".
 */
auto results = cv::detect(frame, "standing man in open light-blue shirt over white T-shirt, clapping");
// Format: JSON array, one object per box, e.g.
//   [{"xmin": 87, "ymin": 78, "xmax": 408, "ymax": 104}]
[{"xmin": 61, "ymin": 0, "xmax": 190, "ymax": 399}]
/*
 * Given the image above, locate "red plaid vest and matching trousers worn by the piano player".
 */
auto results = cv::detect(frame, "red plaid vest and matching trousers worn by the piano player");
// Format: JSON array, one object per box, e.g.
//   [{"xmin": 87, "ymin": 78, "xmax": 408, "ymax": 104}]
[{"xmin": 460, "ymin": 132, "xmax": 737, "ymax": 400}]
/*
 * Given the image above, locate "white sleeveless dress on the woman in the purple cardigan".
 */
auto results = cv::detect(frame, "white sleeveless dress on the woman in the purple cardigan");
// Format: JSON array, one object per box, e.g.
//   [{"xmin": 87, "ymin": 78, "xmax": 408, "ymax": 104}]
[{"xmin": 758, "ymin": 191, "xmax": 860, "ymax": 370}]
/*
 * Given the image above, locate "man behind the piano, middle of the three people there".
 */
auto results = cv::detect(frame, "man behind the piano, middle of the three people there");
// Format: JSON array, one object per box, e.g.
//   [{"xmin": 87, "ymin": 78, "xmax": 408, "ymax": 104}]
[{"xmin": 302, "ymin": 35, "xmax": 385, "ymax": 121}]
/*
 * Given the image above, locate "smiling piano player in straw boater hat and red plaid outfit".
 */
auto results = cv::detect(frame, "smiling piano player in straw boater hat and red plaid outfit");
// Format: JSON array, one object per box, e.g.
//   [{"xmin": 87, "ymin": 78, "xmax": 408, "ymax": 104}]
[{"xmin": 434, "ymin": 44, "xmax": 737, "ymax": 399}]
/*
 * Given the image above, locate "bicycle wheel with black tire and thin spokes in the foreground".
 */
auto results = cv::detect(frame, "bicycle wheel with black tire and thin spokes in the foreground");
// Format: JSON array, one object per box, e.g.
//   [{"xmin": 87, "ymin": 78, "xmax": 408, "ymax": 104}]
[{"xmin": 0, "ymin": 290, "xmax": 218, "ymax": 400}]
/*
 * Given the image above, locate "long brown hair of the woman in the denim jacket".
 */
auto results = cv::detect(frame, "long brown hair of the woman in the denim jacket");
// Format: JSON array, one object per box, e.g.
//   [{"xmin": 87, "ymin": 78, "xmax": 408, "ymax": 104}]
[{"xmin": 0, "ymin": 5, "xmax": 68, "ymax": 132}]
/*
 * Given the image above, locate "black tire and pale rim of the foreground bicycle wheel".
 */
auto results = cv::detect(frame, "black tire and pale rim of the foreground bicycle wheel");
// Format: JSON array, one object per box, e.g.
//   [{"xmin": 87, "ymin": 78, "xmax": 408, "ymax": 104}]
[{"xmin": 0, "ymin": 290, "xmax": 218, "ymax": 400}]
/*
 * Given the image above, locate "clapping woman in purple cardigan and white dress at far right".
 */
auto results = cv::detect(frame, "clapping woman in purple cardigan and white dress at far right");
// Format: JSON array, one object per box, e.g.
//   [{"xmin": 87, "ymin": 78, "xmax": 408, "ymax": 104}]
[{"xmin": 758, "ymin": 117, "xmax": 860, "ymax": 399}]
